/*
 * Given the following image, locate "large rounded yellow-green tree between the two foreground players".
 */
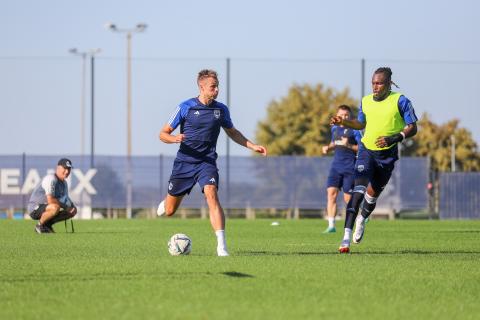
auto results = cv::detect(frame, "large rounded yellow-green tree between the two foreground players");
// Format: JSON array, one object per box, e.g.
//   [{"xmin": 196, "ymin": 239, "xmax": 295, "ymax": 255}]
[{"xmin": 256, "ymin": 84, "xmax": 358, "ymax": 156}]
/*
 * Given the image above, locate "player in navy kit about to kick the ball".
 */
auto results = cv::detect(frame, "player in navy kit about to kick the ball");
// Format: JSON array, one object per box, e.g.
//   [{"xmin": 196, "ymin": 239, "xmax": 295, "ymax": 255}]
[{"xmin": 157, "ymin": 70, "xmax": 267, "ymax": 256}]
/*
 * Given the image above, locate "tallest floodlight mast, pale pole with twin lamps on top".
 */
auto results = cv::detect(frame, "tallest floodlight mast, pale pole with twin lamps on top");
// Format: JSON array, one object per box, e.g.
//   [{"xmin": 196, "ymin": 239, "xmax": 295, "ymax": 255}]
[{"xmin": 105, "ymin": 22, "xmax": 147, "ymax": 219}]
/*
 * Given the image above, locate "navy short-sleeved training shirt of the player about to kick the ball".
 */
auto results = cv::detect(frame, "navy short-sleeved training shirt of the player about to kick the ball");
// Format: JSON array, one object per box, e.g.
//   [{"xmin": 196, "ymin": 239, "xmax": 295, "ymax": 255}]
[{"xmin": 168, "ymin": 98, "xmax": 233, "ymax": 163}]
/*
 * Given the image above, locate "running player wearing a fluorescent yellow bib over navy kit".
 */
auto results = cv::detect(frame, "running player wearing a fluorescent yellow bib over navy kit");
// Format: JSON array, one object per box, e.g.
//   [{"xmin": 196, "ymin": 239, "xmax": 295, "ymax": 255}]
[{"xmin": 331, "ymin": 68, "xmax": 417, "ymax": 253}]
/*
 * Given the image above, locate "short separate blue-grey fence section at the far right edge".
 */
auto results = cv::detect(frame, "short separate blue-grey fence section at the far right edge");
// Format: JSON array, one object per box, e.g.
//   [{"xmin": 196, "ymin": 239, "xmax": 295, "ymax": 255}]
[{"xmin": 439, "ymin": 172, "xmax": 480, "ymax": 219}]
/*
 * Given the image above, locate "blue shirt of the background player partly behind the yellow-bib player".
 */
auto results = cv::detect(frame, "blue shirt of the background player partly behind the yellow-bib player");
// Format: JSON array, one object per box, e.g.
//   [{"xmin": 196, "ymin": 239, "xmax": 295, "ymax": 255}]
[{"xmin": 331, "ymin": 125, "xmax": 362, "ymax": 172}]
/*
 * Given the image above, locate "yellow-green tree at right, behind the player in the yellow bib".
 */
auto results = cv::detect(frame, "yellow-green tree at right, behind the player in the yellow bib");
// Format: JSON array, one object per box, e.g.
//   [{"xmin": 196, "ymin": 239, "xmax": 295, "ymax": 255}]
[{"xmin": 402, "ymin": 113, "xmax": 480, "ymax": 171}]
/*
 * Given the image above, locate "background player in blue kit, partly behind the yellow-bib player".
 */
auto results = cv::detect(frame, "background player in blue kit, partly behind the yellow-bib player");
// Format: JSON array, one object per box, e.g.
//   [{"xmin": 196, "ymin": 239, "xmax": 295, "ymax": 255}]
[{"xmin": 322, "ymin": 105, "xmax": 361, "ymax": 233}]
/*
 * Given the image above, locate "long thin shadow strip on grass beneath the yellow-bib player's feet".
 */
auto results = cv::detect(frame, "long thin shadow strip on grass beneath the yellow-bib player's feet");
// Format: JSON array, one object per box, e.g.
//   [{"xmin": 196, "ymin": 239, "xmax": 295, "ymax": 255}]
[{"xmin": 238, "ymin": 249, "xmax": 480, "ymax": 256}]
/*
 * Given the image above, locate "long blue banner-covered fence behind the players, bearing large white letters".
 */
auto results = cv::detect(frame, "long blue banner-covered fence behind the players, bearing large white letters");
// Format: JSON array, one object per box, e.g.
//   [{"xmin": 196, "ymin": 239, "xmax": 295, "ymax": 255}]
[{"xmin": 0, "ymin": 155, "xmax": 429, "ymax": 215}]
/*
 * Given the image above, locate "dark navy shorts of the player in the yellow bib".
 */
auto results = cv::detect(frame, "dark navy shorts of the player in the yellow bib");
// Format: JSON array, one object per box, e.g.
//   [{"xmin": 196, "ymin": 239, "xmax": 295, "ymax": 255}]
[{"xmin": 355, "ymin": 145, "xmax": 398, "ymax": 192}]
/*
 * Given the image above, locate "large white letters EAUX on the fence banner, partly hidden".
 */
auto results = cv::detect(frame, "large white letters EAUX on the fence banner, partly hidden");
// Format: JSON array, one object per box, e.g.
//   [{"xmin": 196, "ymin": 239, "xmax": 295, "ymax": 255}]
[{"xmin": 0, "ymin": 168, "xmax": 97, "ymax": 195}]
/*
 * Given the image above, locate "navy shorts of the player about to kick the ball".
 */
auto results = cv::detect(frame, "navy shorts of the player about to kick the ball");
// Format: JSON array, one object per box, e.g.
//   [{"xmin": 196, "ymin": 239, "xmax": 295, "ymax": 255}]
[{"xmin": 168, "ymin": 159, "xmax": 218, "ymax": 197}]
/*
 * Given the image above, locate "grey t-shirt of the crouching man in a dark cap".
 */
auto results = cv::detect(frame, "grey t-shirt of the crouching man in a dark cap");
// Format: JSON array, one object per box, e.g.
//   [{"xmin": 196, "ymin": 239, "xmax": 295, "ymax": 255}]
[{"xmin": 28, "ymin": 174, "xmax": 73, "ymax": 212}]
